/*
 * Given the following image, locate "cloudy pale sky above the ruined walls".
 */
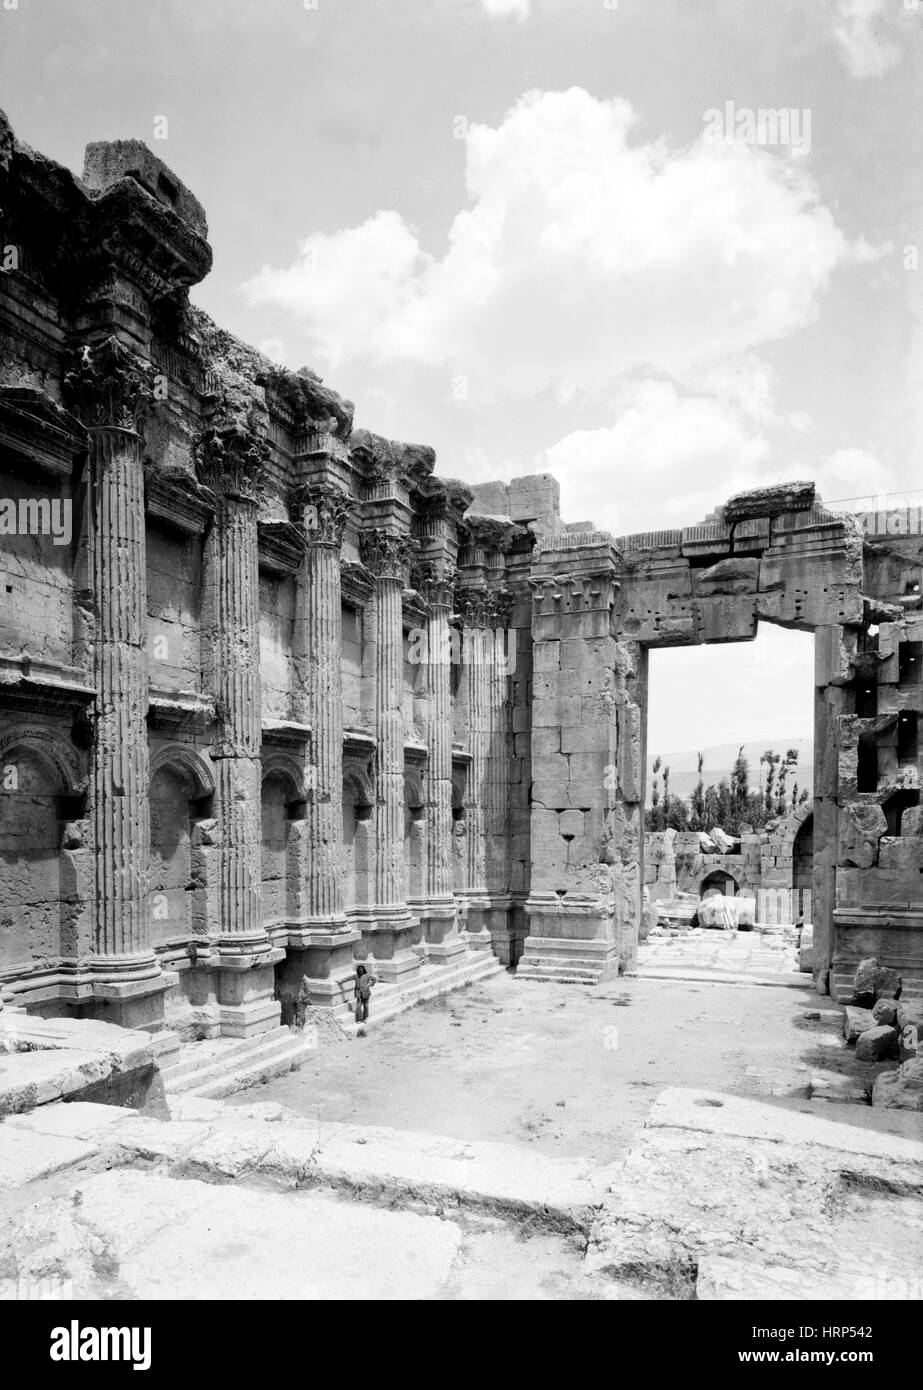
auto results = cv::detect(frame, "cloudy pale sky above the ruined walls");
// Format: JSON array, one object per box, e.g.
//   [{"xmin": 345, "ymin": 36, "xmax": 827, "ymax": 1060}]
[{"xmin": 0, "ymin": 0, "xmax": 923, "ymax": 746}]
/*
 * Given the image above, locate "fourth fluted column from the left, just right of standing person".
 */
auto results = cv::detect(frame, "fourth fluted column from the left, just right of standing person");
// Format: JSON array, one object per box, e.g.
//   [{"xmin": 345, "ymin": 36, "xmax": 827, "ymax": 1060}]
[{"xmin": 360, "ymin": 527, "xmax": 420, "ymax": 983}]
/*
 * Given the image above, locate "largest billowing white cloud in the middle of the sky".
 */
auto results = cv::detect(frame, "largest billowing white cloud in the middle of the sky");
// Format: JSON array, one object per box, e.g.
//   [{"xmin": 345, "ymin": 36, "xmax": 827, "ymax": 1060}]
[{"xmin": 245, "ymin": 88, "xmax": 870, "ymax": 400}]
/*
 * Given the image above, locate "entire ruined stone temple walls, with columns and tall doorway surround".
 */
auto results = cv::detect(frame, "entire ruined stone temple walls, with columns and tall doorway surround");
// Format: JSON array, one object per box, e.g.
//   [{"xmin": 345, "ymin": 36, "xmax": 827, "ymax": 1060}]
[{"xmin": 0, "ymin": 115, "xmax": 923, "ymax": 1037}]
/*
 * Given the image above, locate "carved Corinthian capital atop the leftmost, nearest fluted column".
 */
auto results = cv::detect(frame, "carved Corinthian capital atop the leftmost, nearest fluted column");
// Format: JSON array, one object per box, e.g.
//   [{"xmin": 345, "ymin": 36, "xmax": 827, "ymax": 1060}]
[{"xmin": 64, "ymin": 336, "xmax": 154, "ymax": 434}]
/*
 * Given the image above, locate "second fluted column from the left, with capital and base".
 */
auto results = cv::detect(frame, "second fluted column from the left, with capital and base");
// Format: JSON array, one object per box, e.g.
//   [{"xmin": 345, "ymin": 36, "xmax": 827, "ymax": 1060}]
[{"xmin": 197, "ymin": 430, "xmax": 284, "ymax": 1037}]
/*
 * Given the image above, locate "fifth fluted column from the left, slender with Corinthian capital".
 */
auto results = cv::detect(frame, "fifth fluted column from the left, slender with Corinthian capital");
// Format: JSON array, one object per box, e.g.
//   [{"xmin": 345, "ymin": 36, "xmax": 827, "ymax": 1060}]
[{"xmin": 413, "ymin": 560, "xmax": 464, "ymax": 965}]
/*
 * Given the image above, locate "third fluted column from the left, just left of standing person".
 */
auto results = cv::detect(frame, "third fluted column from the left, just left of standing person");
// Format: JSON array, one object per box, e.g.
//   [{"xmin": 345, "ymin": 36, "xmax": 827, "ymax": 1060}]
[{"xmin": 282, "ymin": 482, "xmax": 360, "ymax": 1005}]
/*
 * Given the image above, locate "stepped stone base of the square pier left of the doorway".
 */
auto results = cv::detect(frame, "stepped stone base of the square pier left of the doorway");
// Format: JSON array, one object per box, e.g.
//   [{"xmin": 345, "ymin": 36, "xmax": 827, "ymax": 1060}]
[{"xmin": 516, "ymin": 892, "xmax": 619, "ymax": 984}]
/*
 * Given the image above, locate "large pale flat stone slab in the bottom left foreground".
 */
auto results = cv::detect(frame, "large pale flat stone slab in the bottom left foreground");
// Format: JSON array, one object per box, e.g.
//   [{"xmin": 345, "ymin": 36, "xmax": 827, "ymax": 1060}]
[{"xmin": 0, "ymin": 1170, "xmax": 462, "ymax": 1301}]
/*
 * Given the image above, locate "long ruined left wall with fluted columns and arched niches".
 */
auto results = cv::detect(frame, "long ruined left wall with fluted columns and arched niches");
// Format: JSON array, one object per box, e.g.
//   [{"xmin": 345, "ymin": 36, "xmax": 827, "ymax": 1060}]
[{"xmin": 0, "ymin": 117, "xmax": 519, "ymax": 1037}]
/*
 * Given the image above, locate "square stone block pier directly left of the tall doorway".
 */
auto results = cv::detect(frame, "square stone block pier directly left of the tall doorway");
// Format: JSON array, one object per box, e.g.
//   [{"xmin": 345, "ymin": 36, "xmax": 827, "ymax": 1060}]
[{"xmin": 518, "ymin": 538, "xmax": 619, "ymax": 983}]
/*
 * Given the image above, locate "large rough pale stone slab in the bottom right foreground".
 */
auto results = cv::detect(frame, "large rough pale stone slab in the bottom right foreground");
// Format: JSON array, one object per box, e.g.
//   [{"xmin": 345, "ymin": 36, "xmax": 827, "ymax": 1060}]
[{"xmin": 587, "ymin": 1088, "xmax": 923, "ymax": 1298}]
